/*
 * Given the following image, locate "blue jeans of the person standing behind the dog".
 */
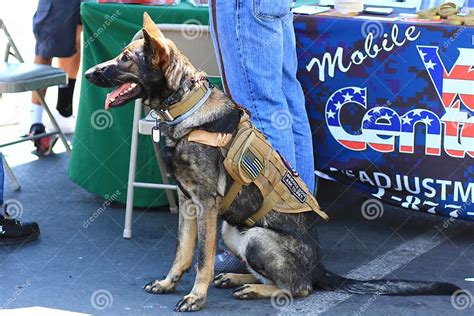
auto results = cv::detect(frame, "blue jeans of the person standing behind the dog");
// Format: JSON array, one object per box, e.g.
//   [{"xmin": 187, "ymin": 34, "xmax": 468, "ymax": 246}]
[{"xmin": 209, "ymin": 0, "xmax": 315, "ymax": 191}]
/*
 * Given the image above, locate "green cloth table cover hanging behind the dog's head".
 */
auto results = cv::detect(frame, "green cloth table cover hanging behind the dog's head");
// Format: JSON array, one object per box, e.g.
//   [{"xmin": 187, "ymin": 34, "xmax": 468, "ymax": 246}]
[{"xmin": 69, "ymin": 3, "xmax": 209, "ymax": 207}]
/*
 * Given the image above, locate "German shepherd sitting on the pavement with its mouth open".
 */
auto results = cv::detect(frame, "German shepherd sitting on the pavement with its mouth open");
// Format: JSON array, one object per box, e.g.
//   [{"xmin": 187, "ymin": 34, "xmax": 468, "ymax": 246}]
[{"xmin": 85, "ymin": 13, "xmax": 459, "ymax": 312}]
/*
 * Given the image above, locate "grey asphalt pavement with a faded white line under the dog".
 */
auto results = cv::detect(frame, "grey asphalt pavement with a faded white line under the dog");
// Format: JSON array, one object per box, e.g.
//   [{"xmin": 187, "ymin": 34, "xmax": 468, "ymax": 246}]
[{"xmin": 0, "ymin": 152, "xmax": 474, "ymax": 315}]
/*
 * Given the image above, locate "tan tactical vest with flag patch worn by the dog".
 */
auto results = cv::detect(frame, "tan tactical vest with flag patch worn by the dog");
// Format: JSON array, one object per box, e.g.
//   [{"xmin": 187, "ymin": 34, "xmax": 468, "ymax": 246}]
[{"xmin": 188, "ymin": 113, "xmax": 328, "ymax": 226}]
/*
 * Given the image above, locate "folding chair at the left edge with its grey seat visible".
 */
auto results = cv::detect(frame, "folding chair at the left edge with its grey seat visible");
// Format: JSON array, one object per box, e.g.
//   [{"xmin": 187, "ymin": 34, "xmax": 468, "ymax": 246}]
[{"xmin": 0, "ymin": 19, "xmax": 71, "ymax": 190}]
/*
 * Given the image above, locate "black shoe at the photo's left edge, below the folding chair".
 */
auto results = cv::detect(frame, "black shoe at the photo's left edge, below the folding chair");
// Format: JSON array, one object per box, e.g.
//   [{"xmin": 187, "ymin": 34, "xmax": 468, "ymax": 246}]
[{"xmin": 0, "ymin": 211, "xmax": 40, "ymax": 245}]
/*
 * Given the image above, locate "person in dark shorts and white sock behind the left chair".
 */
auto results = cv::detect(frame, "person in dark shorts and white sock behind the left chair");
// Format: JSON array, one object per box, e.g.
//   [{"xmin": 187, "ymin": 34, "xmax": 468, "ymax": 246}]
[{"xmin": 30, "ymin": 0, "xmax": 82, "ymax": 155}]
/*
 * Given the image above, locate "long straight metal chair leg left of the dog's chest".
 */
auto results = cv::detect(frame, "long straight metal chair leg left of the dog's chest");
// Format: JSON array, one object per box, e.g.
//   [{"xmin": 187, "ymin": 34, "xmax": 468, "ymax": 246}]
[{"xmin": 123, "ymin": 99, "xmax": 142, "ymax": 239}]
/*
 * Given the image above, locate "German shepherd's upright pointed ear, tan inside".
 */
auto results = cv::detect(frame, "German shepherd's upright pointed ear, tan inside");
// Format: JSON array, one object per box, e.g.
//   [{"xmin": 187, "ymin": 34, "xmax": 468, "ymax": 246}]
[{"xmin": 142, "ymin": 12, "xmax": 170, "ymax": 67}]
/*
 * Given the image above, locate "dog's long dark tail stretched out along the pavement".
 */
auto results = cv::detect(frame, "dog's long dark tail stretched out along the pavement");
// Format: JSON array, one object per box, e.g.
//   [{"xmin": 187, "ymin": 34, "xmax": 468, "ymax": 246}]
[{"xmin": 315, "ymin": 269, "xmax": 460, "ymax": 295}]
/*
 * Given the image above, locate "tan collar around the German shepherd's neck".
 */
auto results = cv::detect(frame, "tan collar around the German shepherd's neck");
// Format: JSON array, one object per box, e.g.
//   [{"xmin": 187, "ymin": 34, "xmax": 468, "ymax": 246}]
[{"xmin": 155, "ymin": 80, "xmax": 212, "ymax": 125}]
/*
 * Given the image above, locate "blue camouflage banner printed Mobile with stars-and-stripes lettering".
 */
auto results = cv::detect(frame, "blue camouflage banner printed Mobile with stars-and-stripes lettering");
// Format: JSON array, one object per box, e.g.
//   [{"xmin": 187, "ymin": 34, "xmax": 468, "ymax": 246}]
[{"xmin": 295, "ymin": 16, "xmax": 474, "ymax": 220}]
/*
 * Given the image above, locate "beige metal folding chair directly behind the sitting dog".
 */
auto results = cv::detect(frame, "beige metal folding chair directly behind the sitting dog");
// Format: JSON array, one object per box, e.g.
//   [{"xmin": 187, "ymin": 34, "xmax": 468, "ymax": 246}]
[{"xmin": 123, "ymin": 24, "xmax": 219, "ymax": 239}]
